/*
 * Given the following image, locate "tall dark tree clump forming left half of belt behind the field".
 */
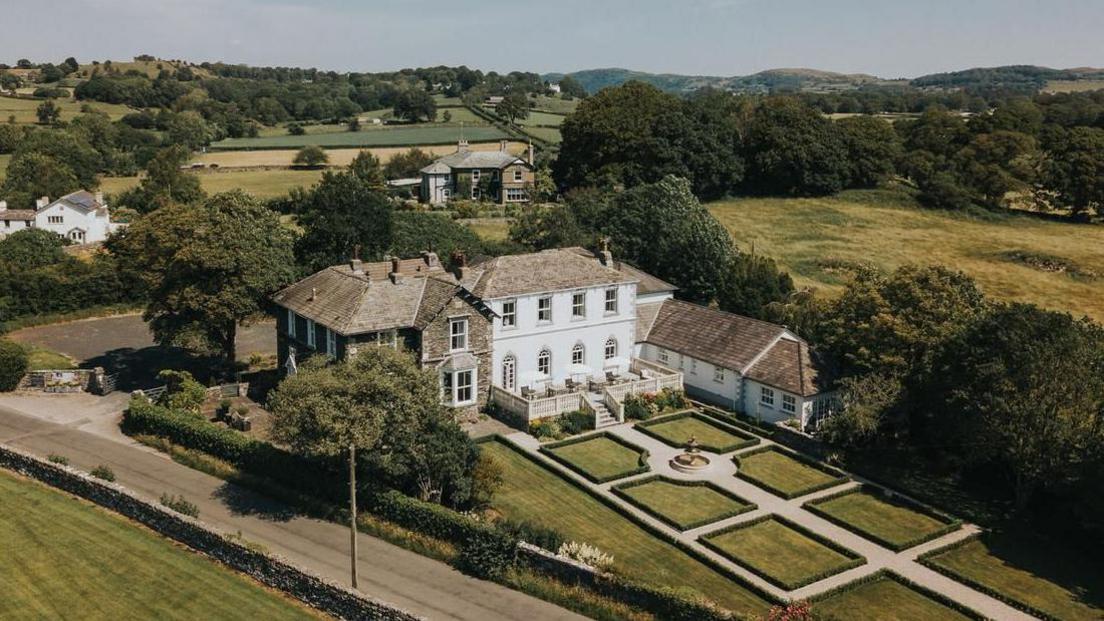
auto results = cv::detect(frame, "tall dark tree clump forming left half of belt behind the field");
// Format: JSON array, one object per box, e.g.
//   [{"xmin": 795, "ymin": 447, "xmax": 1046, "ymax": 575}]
[{"xmin": 553, "ymin": 82, "xmax": 900, "ymax": 199}]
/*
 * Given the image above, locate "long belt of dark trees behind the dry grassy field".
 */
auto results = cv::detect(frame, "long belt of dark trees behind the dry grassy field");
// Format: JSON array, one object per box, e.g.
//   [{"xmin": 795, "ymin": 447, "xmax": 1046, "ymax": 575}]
[{"xmin": 553, "ymin": 82, "xmax": 1104, "ymax": 215}]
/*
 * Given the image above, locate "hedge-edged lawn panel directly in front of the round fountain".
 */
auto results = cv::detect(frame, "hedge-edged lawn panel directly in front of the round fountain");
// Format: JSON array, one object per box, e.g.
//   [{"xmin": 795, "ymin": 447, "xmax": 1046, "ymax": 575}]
[{"xmin": 614, "ymin": 477, "xmax": 755, "ymax": 530}]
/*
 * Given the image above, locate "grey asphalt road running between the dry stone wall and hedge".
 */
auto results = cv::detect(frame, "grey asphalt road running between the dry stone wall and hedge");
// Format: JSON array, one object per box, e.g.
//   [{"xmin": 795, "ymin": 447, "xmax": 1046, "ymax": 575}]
[{"xmin": 0, "ymin": 394, "xmax": 584, "ymax": 621}]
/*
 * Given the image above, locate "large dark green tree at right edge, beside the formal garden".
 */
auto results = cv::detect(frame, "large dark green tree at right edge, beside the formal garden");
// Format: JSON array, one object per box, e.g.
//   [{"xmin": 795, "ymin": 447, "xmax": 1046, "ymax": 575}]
[{"xmin": 913, "ymin": 304, "xmax": 1104, "ymax": 508}]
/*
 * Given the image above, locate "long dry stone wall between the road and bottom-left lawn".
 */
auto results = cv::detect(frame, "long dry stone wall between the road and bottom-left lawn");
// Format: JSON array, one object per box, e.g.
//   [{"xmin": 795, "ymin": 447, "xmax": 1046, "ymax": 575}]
[{"xmin": 0, "ymin": 446, "xmax": 420, "ymax": 621}]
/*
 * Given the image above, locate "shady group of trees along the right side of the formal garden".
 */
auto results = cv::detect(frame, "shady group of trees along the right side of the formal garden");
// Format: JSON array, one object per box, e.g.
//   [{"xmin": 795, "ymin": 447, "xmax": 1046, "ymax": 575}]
[{"xmin": 799, "ymin": 266, "xmax": 1104, "ymax": 537}]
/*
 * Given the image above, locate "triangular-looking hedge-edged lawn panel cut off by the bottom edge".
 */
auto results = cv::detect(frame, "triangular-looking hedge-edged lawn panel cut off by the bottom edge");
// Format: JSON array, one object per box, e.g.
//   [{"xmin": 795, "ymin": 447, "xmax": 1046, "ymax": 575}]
[{"xmin": 813, "ymin": 577, "xmax": 972, "ymax": 621}]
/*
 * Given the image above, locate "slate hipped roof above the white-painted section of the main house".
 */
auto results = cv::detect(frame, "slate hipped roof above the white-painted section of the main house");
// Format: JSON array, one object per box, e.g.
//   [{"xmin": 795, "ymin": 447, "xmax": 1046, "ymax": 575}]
[{"xmin": 470, "ymin": 249, "xmax": 637, "ymax": 299}]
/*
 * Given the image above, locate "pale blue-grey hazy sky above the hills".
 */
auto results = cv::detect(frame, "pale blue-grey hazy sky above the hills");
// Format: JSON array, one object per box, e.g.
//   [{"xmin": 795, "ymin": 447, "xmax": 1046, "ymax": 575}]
[{"xmin": 8, "ymin": 0, "xmax": 1104, "ymax": 77}]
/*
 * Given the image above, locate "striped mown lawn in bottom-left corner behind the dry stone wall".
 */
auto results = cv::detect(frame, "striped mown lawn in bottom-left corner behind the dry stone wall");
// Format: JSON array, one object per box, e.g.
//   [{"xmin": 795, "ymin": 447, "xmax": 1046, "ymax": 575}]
[{"xmin": 0, "ymin": 471, "xmax": 319, "ymax": 620}]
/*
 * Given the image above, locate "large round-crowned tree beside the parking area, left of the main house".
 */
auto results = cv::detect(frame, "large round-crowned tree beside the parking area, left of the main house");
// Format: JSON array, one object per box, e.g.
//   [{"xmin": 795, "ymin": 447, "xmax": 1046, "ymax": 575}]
[{"xmin": 108, "ymin": 190, "xmax": 294, "ymax": 364}]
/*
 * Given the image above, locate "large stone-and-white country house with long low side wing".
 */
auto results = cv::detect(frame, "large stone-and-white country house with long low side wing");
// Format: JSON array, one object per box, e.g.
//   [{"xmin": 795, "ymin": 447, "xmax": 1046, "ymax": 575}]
[{"xmin": 273, "ymin": 246, "xmax": 834, "ymax": 428}]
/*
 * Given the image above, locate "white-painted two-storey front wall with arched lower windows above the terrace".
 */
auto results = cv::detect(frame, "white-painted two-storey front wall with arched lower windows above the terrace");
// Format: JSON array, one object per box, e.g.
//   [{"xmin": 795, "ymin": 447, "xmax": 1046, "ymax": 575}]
[{"xmin": 487, "ymin": 283, "xmax": 636, "ymax": 391}]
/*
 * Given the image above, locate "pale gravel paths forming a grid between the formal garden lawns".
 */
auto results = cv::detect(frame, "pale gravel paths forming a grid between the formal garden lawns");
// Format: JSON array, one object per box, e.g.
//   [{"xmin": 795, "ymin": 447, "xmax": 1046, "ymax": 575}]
[{"xmin": 506, "ymin": 423, "xmax": 1033, "ymax": 621}]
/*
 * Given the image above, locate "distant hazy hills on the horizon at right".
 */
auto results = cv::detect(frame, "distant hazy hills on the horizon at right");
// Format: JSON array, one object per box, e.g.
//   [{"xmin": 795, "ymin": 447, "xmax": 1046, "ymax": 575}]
[{"xmin": 541, "ymin": 65, "xmax": 1104, "ymax": 93}]
